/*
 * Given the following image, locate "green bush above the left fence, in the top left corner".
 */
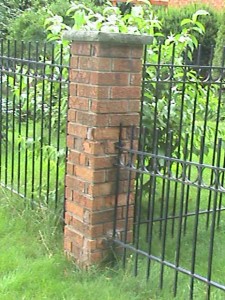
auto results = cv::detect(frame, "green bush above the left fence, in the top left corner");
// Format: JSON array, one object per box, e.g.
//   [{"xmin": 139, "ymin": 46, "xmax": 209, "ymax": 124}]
[{"xmin": 0, "ymin": 0, "xmax": 70, "ymax": 41}]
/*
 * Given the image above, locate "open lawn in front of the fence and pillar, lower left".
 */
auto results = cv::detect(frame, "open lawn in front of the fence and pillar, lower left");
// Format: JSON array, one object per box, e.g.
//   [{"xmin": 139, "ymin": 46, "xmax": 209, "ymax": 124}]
[{"xmin": 0, "ymin": 191, "xmax": 162, "ymax": 300}]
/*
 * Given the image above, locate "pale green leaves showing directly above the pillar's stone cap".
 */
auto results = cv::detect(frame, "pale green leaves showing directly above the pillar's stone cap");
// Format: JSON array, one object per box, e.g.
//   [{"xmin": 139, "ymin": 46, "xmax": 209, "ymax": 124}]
[{"xmin": 47, "ymin": 3, "xmax": 161, "ymax": 38}]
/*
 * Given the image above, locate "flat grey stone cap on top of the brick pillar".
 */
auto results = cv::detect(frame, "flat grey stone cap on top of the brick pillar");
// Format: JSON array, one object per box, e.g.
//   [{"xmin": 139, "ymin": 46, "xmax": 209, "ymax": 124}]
[{"xmin": 63, "ymin": 30, "xmax": 153, "ymax": 45}]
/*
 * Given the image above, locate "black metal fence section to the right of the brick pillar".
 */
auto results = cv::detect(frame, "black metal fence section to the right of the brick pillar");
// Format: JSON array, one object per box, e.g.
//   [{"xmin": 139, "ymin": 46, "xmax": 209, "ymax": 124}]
[{"xmin": 114, "ymin": 46, "xmax": 225, "ymax": 299}]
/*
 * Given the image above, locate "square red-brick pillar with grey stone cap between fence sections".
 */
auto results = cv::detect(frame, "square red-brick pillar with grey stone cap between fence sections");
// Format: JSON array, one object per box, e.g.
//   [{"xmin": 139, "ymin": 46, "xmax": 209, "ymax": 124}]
[{"xmin": 64, "ymin": 32, "xmax": 150, "ymax": 266}]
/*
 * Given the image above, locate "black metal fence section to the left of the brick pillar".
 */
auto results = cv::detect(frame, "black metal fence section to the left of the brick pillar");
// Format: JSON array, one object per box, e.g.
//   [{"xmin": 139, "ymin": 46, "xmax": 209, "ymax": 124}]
[{"xmin": 0, "ymin": 40, "xmax": 69, "ymax": 206}]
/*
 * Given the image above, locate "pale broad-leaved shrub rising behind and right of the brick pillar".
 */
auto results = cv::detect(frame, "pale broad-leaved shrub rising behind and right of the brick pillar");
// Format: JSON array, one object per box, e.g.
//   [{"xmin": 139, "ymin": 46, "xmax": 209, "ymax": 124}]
[{"xmin": 47, "ymin": 3, "xmax": 215, "ymax": 159}]
